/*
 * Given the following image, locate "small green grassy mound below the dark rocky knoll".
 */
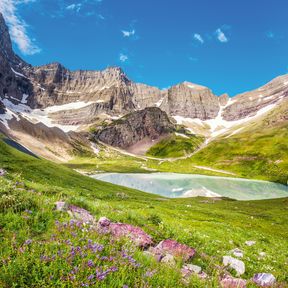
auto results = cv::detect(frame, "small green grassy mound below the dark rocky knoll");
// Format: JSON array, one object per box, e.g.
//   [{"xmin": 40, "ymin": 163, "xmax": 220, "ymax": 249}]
[{"xmin": 147, "ymin": 134, "xmax": 204, "ymax": 158}]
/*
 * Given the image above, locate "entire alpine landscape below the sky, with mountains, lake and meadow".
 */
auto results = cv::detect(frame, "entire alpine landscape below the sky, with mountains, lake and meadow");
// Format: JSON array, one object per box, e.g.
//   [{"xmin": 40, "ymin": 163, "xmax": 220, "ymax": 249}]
[{"xmin": 0, "ymin": 7, "xmax": 288, "ymax": 288}]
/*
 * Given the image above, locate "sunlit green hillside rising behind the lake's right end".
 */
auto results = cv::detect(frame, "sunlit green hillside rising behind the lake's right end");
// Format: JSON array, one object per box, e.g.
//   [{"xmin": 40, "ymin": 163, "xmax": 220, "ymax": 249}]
[{"xmin": 147, "ymin": 102, "xmax": 288, "ymax": 184}]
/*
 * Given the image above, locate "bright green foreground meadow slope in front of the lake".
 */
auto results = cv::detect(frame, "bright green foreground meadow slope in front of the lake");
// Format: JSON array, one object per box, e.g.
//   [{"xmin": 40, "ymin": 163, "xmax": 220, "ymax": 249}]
[{"xmin": 0, "ymin": 137, "xmax": 288, "ymax": 287}]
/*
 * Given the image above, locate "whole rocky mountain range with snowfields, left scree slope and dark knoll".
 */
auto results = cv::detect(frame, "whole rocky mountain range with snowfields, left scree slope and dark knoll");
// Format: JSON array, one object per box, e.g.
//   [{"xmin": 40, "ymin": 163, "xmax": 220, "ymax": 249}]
[{"xmin": 0, "ymin": 14, "xmax": 288, "ymax": 182}]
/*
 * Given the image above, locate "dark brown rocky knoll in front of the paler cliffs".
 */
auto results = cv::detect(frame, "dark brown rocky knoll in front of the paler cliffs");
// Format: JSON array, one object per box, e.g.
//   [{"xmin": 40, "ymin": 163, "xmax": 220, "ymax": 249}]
[{"xmin": 95, "ymin": 107, "xmax": 175, "ymax": 148}]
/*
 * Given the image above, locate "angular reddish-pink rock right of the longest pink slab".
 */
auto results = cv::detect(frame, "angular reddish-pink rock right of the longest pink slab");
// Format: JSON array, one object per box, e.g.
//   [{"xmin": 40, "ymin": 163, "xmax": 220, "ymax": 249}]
[{"xmin": 151, "ymin": 239, "xmax": 196, "ymax": 261}]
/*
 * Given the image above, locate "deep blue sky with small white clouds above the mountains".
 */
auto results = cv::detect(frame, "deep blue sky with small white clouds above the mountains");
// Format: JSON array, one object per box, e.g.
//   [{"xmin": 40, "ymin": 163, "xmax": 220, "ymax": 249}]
[{"xmin": 0, "ymin": 0, "xmax": 288, "ymax": 96}]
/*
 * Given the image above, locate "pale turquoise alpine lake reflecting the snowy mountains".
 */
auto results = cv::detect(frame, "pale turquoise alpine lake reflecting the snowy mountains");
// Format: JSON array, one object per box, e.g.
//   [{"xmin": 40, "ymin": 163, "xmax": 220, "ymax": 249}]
[{"xmin": 91, "ymin": 173, "xmax": 288, "ymax": 200}]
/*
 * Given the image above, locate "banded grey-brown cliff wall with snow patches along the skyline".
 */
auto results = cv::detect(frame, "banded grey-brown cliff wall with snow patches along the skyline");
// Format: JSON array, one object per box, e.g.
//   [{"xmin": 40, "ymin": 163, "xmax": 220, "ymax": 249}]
[{"xmin": 0, "ymin": 14, "xmax": 288, "ymax": 153}]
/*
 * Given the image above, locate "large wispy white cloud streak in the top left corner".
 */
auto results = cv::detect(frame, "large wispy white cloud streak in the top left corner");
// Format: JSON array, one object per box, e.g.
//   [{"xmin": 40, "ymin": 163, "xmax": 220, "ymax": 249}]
[{"xmin": 0, "ymin": 0, "xmax": 41, "ymax": 55}]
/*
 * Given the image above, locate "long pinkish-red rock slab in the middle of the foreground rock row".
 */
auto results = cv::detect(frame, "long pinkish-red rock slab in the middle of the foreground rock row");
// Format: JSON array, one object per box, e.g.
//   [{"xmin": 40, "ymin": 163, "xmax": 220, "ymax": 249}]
[{"xmin": 98, "ymin": 217, "xmax": 153, "ymax": 248}]
